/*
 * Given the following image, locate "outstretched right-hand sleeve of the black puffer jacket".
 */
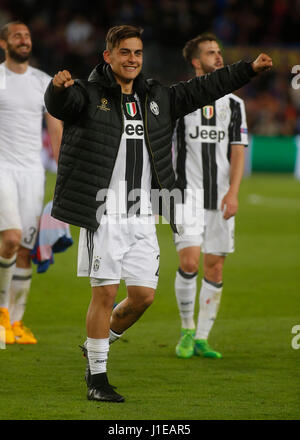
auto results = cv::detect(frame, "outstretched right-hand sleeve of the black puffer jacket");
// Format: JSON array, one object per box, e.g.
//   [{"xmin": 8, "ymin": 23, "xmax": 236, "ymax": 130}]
[{"xmin": 170, "ymin": 61, "xmax": 256, "ymax": 119}]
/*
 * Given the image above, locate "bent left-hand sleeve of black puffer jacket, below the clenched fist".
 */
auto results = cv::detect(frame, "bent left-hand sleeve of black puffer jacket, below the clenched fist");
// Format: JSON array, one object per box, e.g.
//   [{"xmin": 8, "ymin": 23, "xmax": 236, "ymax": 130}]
[{"xmin": 44, "ymin": 80, "xmax": 88, "ymax": 122}]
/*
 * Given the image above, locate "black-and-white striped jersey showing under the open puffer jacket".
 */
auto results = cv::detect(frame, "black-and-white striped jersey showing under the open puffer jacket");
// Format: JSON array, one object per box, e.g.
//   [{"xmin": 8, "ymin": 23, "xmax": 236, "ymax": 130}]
[{"xmin": 106, "ymin": 95, "xmax": 152, "ymax": 215}]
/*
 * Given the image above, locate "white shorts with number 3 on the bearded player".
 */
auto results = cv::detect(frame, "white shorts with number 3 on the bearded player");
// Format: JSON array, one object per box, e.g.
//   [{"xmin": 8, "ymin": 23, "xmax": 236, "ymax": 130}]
[{"xmin": 0, "ymin": 169, "xmax": 45, "ymax": 249}]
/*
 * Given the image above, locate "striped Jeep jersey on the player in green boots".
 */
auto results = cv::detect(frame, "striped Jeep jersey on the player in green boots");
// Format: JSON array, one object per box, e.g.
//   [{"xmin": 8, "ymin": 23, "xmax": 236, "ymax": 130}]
[{"xmin": 174, "ymin": 94, "xmax": 248, "ymax": 209}]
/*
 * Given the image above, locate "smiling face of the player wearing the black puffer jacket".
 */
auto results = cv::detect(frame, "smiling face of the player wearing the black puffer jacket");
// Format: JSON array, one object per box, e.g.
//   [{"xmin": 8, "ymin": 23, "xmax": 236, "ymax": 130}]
[{"xmin": 103, "ymin": 37, "xmax": 143, "ymax": 93}]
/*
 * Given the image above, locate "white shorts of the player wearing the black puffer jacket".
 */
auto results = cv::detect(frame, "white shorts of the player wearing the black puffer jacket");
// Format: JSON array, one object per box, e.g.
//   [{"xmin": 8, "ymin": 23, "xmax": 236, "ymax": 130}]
[{"xmin": 77, "ymin": 215, "xmax": 159, "ymax": 289}]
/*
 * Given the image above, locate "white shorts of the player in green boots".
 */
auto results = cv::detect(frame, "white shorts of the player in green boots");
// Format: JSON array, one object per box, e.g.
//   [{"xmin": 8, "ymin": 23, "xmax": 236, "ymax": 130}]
[{"xmin": 174, "ymin": 209, "xmax": 235, "ymax": 256}]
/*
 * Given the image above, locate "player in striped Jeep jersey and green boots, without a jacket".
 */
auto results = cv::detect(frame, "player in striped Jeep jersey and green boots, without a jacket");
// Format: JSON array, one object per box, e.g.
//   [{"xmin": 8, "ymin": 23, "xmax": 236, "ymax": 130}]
[{"xmin": 175, "ymin": 34, "xmax": 248, "ymax": 358}]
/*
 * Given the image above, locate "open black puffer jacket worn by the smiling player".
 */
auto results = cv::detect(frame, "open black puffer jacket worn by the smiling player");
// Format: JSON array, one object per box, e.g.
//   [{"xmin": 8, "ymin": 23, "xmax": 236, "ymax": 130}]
[{"xmin": 45, "ymin": 61, "xmax": 255, "ymax": 231}]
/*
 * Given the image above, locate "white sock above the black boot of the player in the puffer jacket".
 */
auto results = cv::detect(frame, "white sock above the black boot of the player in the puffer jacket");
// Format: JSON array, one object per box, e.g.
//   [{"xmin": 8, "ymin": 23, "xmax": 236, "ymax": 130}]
[{"xmin": 86, "ymin": 338, "xmax": 109, "ymax": 375}]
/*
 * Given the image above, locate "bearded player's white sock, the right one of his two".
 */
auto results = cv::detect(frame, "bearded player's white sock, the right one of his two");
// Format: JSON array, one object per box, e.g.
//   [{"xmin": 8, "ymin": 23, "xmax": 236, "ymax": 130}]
[{"xmin": 9, "ymin": 267, "xmax": 32, "ymax": 324}]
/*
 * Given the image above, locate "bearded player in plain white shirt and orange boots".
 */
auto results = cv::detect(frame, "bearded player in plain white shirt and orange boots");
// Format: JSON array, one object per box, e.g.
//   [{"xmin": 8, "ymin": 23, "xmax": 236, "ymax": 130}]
[{"xmin": 0, "ymin": 21, "xmax": 62, "ymax": 344}]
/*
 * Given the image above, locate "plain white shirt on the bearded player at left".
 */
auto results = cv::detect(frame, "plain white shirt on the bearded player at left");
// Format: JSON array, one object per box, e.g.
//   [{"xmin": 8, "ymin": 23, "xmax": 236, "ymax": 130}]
[{"xmin": 0, "ymin": 63, "xmax": 51, "ymax": 170}]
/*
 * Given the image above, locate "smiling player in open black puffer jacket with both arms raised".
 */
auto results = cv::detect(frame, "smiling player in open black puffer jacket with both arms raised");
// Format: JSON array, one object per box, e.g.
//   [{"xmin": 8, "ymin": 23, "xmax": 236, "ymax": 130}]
[{"xmin": 45, "ymin": 25, "xmax": 272, "ymax": 402}]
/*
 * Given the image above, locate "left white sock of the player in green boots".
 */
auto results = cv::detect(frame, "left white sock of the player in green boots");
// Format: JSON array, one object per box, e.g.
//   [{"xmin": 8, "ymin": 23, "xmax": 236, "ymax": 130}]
[{"xmin": 175, "ymin": 268, "xmax": 198, "ymax": 329}]
